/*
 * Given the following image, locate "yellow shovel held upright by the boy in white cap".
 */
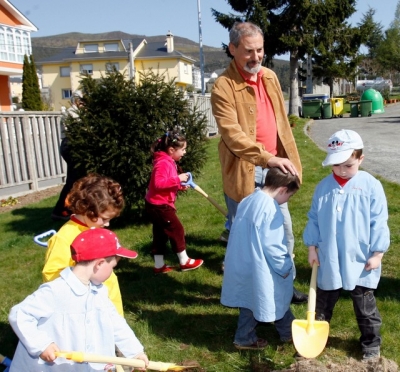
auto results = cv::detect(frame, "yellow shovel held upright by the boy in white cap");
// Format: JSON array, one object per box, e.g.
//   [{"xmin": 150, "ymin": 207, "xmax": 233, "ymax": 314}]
[{"xmin": 292, "ymin": 262, "xmax": 329, "ymax": 358}]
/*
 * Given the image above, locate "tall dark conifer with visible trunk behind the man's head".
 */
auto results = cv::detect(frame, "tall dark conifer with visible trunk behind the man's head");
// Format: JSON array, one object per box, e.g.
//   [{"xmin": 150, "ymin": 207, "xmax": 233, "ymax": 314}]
[{"xmin": 212, "ymin": 0, "xmax": 363, "ymax": 114}]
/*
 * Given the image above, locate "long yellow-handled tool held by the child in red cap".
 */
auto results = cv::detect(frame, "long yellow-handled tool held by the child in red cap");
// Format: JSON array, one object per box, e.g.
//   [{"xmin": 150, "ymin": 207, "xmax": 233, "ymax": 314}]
[{"xmin": 55, "ymin": 351, "xmax": 195, "ymax": 371}]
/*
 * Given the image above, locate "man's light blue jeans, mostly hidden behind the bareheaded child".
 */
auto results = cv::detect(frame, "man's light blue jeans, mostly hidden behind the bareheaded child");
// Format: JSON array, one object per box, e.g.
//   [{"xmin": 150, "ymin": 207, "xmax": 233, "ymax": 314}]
[{"xmin": 224, "ymin": 166, "xmax": 296, "ymax": 279}]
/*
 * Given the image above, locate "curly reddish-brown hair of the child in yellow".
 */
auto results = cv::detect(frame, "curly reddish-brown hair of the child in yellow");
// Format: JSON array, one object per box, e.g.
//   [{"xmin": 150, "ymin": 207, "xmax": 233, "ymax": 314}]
[{"xmin": 66, "ymin": 174, "xmax": 124, "ymax": 221}]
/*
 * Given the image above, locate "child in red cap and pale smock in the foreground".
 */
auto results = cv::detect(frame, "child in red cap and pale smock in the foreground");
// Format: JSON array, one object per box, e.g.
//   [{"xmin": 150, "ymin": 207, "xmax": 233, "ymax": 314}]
[{"xmin": 9, "ymin": 228, "xmax": 149, "ymax": 372}]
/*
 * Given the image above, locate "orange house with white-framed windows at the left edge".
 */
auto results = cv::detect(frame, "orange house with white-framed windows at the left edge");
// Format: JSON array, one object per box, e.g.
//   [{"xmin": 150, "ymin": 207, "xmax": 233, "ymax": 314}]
[{"xmin": 0, "ymin": 0, "xmax": 38, "ymax": 111}]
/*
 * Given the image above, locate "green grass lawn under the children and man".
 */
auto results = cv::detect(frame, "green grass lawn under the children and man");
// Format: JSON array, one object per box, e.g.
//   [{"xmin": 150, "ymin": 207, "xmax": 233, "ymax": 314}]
[{"xmin": 0, "ymin": 120, "xmax": 400, "ymax": 372}]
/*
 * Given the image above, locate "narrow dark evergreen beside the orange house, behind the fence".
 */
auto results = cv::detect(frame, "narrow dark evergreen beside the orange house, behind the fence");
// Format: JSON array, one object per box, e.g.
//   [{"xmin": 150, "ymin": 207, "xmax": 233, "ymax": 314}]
[{"xmin": 22, "ymin": 54, "xmax": 43, "ymax": 111}]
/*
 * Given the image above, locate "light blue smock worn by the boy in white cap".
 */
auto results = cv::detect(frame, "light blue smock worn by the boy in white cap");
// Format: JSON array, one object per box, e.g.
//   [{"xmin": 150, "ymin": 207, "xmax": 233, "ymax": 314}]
[{"xmin": 303, "ymin": 171, "xmax": 390, "ymax": 291}]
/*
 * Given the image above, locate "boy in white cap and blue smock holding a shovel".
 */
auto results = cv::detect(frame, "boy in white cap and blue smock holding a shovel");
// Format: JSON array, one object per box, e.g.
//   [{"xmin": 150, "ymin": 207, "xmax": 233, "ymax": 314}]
[{"xmin": 303, "ymin": 129, "xmax": 390, "ymax": 360}]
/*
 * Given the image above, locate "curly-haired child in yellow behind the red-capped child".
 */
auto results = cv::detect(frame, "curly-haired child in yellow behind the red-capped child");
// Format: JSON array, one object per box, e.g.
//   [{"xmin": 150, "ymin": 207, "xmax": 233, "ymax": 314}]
[{"xmin": 42, "ymin": 174, "xmax": 124, "ymax": 315}]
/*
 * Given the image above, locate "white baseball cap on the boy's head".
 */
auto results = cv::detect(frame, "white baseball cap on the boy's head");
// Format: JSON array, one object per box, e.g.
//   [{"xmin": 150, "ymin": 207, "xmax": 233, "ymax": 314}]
[{"xmin": 322, "ymin": 129, "xmax": 364, "ymax": 167}]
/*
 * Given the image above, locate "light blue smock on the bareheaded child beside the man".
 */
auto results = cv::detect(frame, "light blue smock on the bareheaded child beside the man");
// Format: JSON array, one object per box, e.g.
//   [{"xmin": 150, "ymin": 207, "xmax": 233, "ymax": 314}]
[{"xmin": 221, "ymin": 189, "xmax": 293, "ymax": 322}]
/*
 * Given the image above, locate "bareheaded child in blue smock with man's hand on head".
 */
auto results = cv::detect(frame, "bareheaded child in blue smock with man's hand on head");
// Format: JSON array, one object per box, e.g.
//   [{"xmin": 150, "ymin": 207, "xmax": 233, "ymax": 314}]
[{"xmin": 221, "ymin": 168, "xmax": 300, "ymax": 350}]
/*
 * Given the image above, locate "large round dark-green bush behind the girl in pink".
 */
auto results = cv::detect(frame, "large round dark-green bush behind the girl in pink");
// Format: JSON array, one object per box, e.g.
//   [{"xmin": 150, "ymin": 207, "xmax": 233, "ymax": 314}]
[{"xmin": 66, "ymin": 71, "xmax": 207, "ymax": 211}]
